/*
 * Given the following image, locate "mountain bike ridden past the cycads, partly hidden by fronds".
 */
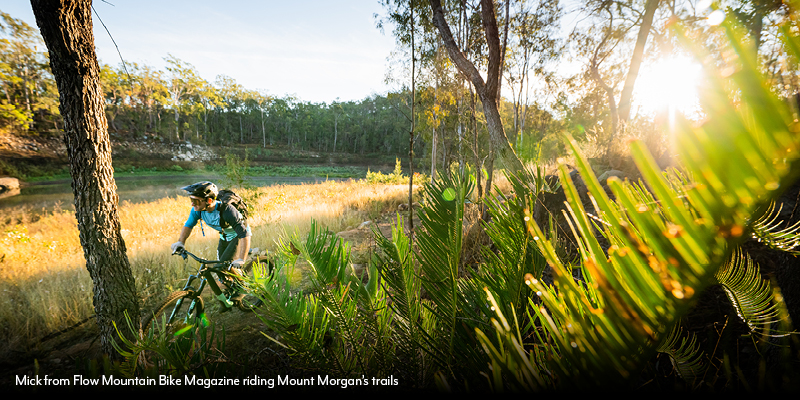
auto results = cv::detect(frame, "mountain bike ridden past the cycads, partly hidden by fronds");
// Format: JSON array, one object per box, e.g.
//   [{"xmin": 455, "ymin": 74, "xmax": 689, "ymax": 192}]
[{"xmin": 142, "ymin": 248, "xmax": 274, "ymax": 331}]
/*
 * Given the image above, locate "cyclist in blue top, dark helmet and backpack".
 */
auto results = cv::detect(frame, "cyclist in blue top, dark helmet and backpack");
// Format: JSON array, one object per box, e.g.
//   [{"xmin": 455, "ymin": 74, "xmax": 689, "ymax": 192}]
[{"xmin": 171, "ymin": 181, "xmax": 252, "ymax": 275}]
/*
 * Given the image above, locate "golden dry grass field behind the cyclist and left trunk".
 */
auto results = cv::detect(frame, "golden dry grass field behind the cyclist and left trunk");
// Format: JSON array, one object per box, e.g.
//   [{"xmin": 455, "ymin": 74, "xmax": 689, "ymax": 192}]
[{"xmin": 0, "ymin": 181, "xmax": 408, "ymax": 347}]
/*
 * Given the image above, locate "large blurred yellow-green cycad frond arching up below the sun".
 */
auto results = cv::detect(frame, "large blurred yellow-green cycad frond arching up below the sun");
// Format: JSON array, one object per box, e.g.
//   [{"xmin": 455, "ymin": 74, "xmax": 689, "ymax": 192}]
[{"xmin": 488, "ymin": 20, "xmax": 800, "ymax": 386}]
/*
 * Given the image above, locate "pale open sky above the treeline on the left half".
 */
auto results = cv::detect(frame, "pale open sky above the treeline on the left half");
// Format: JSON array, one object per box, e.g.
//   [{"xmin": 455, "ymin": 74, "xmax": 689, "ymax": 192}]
[{"xmin": 0, "ymin": 0, "xmax": 395, "ymax": 103}]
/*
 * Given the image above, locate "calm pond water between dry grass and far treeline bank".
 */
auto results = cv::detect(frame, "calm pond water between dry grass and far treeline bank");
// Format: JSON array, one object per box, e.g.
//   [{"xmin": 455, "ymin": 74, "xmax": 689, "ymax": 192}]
[{"xmin": 0, "ymin": 175, "xmax": 343, "ymax": 215}]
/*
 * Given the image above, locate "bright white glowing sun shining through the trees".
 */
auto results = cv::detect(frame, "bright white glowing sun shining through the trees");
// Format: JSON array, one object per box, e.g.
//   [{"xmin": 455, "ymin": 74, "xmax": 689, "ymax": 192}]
[{"xmin": 633, "ymin": 56, "xmax": 702, "ymax": 119}]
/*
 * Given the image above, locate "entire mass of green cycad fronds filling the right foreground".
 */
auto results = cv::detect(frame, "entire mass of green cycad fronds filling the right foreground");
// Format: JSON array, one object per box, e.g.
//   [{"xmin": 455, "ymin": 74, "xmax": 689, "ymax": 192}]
[{"xmin": 245, "ymin": 14, "xmax": 800, "ymax": 391}]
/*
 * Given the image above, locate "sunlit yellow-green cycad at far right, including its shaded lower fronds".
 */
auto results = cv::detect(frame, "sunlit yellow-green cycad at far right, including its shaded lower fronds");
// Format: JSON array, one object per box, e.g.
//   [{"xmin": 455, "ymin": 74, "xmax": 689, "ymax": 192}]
[{"xmin": 472, "ymin": 15, "xmax": 800, "ymax": 389}]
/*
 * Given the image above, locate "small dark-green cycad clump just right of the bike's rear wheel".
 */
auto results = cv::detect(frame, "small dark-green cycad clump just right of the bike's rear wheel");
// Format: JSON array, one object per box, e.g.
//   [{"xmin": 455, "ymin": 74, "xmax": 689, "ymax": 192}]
[{"xmin": 247, "ymin": 224, "xmax": 392, "ymax": 378}]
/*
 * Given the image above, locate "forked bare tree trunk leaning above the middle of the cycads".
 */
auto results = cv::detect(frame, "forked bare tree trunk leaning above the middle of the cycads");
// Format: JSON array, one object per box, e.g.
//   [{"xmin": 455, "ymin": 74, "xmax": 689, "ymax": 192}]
[{"xmin": 429, "ymin": 0, "xmax": 524, "ymax": 175}]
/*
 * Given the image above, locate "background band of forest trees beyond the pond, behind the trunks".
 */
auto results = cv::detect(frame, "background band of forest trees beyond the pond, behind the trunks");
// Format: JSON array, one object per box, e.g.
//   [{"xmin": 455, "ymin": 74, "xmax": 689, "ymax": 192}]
[{"xmin": 0, "ymin": 0, "xmax": 800, "ymax": 170}]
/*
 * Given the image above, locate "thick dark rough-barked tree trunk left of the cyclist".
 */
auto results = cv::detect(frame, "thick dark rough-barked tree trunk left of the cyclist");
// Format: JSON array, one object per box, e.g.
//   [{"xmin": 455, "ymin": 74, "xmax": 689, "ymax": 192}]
[{"xmin": 31, "ymin": 0, "xmax": 139, "ymax": 358}]
